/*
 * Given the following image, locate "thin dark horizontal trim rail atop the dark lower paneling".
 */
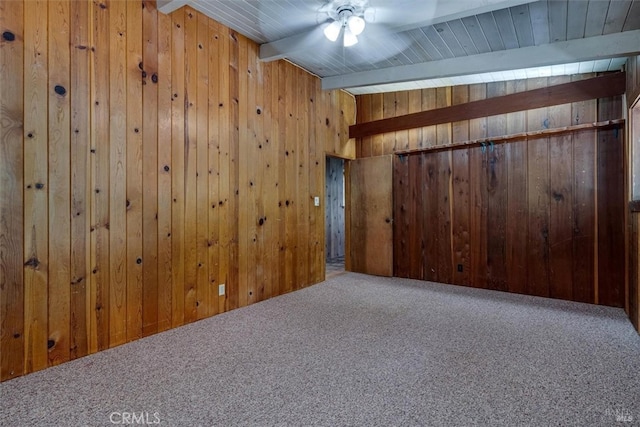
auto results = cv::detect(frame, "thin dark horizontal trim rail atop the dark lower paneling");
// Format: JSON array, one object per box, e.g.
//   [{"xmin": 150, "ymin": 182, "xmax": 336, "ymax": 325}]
[{"xmin": 395, "ymin": 119, "xmax": 625, "ymax": 154}]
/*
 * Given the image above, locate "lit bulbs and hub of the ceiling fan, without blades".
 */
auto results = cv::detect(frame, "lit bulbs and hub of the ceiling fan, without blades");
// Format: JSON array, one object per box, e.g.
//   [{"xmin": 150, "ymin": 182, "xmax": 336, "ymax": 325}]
[{"xmin": 319, "ymin": 0, "xmax": 376, "ymax": 47}]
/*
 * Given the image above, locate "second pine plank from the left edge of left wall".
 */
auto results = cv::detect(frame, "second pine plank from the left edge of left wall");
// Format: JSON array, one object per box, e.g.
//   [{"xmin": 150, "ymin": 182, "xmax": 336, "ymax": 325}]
[{"xmin": 23, "ymin": 1, "xmax": 49, "ymax": 372}]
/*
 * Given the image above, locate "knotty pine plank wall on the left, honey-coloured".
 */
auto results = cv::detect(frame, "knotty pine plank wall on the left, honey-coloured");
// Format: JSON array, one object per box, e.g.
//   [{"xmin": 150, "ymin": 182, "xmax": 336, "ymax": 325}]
[{"xmin": 0, "ymin": 0, "xmax": 355, "ymax": 380}]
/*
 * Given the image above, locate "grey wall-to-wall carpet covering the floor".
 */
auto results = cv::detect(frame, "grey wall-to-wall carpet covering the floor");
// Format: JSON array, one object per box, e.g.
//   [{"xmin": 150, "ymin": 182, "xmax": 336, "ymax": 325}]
[{"xmin": 0, "ymin": 273, "xmax": 640, "ymax": 426}]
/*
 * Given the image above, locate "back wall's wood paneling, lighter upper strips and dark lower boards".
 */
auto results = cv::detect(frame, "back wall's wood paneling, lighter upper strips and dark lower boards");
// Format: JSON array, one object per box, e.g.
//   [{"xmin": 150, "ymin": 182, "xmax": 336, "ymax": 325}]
[{"xmin": 356, "ymin": 76, "xmax": 625, "ymax": 306}]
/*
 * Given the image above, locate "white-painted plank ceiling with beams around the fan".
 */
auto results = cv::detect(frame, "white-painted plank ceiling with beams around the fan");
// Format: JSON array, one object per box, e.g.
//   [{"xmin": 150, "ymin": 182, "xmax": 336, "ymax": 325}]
[{"xmin": 159, "ymin": 0, "xmax": 640, "ymax": 94}]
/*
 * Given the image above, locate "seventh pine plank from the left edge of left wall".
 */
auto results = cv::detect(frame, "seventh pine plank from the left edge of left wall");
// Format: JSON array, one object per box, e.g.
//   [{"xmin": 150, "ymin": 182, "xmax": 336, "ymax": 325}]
[{"xmin": 125, "ymin": 2, "xmax": 144, "ymax": 341}]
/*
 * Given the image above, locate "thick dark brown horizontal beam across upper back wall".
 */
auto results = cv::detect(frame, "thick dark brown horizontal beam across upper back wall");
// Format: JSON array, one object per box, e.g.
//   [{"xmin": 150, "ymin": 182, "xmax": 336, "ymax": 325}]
[{"xmin": 349, "ymin": 72, "xmax": 626, "ymax": 138}]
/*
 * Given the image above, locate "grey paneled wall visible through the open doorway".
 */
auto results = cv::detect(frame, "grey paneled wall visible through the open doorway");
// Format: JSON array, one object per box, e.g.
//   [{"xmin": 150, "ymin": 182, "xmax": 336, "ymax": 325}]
[{"xmin": 325, "ymin": 157, "xmax": 345, "ymax": 261}]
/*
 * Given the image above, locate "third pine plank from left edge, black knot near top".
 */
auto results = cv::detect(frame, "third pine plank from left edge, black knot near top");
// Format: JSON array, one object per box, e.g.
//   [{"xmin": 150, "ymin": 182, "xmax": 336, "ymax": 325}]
[{"xmin": 47, "ymin": 1, "xmax": 71, "ymax": 365}]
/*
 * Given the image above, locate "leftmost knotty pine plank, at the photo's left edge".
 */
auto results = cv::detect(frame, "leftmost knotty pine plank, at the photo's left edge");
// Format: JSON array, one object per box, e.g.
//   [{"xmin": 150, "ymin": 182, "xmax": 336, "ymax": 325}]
[{"xmin": 0, "ymin": 2, "xmax": 27, "ymax": 381}]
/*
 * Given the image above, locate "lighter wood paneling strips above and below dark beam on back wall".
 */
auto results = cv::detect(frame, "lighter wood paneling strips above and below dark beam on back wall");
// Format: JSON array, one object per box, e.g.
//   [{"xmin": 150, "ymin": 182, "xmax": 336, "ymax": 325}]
[{"xmin": 356, "ymin": 74, "xmax": 622, "ymax": 158}]
